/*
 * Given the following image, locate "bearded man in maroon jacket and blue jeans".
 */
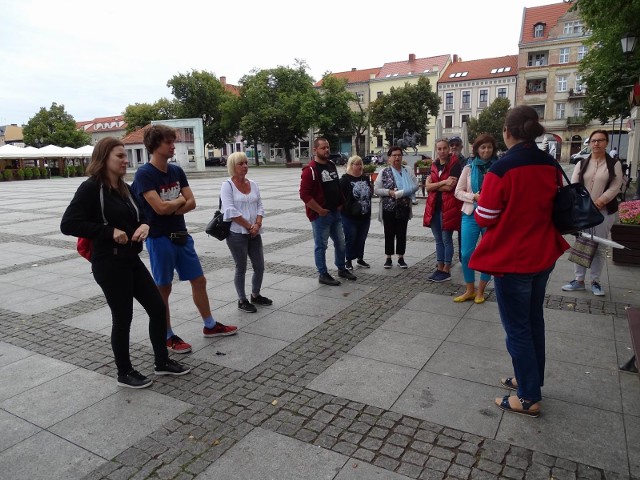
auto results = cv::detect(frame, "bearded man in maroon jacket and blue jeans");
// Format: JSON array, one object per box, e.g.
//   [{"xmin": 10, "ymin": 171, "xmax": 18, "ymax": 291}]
[{"xmin": 300, "ymin": 137, "xmax": 357, "ymax": 286}]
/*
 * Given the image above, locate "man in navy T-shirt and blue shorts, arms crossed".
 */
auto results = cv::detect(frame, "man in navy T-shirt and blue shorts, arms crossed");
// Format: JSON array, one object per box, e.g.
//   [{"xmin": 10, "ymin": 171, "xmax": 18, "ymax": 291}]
[{"xmin": 132, "ymin": 125, "xmax": 238, "ymax": 353}]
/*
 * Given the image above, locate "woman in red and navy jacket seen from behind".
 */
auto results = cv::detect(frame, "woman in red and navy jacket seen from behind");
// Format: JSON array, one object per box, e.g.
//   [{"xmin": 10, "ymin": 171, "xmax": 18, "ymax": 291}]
[{"xmin": 469, "ymin": 106, "xmax": 569, "ymax": 417}]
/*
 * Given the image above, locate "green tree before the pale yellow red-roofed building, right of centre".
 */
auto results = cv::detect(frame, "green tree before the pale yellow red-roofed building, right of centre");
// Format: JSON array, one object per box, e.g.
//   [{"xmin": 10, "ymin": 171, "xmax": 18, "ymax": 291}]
[{"xmin": 370, "ymin": 77, "xmax": 440, "ymax": 143}]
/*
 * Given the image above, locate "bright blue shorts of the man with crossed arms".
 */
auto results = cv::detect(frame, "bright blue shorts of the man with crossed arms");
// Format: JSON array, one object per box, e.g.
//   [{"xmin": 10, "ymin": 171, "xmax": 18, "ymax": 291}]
[{"xmin": 146, "ymin": 235, "xmax": 203, "ymax": 287}]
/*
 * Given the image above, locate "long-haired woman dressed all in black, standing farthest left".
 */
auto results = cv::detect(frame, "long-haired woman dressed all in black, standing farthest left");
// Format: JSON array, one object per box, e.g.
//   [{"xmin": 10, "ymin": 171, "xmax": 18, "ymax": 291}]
[{"xmin": 60, "ymin": 137, "xmax": 191, "ymax": 388}]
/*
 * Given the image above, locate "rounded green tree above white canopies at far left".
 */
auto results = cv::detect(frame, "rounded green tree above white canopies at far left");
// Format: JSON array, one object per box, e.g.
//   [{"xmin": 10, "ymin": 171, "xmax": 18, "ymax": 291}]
[{"xmin": 22, "ymin": 102, "xmax": 91, "ymax": 148}]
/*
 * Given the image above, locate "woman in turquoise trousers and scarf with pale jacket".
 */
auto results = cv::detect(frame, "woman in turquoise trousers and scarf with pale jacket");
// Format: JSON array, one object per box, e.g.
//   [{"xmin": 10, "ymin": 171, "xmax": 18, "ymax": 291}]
[{"xmin": 453, "ymin": 133, "xmax": 498, "ymax": 304}]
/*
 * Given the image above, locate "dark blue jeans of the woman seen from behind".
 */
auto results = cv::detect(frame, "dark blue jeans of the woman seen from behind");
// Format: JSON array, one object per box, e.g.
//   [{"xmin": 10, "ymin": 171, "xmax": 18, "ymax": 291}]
[{"xmin": 494, "ymin": 267, "xmax": 553, "ymax": 402}]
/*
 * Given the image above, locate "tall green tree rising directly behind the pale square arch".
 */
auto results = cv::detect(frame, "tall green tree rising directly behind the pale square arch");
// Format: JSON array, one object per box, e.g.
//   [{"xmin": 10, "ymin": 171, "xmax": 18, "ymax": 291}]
[{"xmin": 167, "ymin": 70, "xmax": 236, "ymax": 148}]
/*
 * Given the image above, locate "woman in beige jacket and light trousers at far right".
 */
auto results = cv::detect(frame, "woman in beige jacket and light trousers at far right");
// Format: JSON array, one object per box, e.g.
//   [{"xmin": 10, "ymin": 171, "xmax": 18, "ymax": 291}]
[{"xmin": 562, "ymin": 130, "xmax": 622, "ymax": 297}]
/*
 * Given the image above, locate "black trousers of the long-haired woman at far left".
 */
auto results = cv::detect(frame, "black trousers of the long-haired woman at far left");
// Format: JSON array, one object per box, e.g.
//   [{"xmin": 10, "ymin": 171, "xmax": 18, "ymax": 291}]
[{"xmin": 92, "ymin": 256, "xmax": 169, "ymax": 375}]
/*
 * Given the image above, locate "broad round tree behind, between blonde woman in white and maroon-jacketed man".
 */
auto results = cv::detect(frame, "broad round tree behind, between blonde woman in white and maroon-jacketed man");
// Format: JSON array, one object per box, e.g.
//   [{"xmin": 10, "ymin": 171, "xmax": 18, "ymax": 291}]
[{"xmin": 239, "ymin": 61, "xmax": 319, "ymax": 162}]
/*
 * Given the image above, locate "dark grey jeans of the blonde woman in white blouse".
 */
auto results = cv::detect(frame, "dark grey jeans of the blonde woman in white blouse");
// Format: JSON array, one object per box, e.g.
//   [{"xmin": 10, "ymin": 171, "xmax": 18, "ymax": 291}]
[{"xmin": 227, "ymin": 232, "xmax": 264, "ymax": 300}]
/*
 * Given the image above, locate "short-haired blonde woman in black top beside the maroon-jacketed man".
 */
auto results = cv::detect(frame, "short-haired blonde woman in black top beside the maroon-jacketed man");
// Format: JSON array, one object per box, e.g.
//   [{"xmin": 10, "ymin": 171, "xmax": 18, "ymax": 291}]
[{"xmin": 340, "ymin": 155, "xmax": 373, "ymax": 270}]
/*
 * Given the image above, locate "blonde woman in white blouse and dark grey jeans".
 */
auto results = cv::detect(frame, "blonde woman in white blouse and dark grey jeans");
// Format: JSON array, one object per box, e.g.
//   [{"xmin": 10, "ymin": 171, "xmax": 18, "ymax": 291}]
[{"xmin": 220, "ymin": 152, "xmax": 273, "ymax": 313}]
